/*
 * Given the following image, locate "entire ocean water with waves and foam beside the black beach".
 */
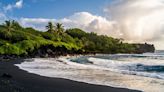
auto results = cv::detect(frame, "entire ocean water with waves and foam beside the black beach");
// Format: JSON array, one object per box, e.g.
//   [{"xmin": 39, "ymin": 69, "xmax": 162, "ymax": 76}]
[{"xmin": 16, "ymin": 51, "xmax": 164, "ymax": 92}]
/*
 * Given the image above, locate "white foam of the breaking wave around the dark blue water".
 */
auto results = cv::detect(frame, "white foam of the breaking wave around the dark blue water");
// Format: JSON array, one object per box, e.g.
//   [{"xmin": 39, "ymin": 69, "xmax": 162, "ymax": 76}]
[{"xmin": 88, "ymin": 57, "xmax": 164, "ymax": 79}]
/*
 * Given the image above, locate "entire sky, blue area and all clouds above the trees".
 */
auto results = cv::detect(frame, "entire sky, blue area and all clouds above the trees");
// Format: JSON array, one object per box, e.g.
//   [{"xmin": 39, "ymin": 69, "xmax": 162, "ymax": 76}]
[{"xmin": 0, "ymin": 0, "xmax": 164, "ymax": 50}]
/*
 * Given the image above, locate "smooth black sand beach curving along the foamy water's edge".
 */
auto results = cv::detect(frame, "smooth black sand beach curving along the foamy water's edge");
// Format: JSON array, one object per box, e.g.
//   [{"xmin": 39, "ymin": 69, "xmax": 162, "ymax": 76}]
[{"xmin": 0, "ymin": 60, "xmax": 139, "ymax": 92}]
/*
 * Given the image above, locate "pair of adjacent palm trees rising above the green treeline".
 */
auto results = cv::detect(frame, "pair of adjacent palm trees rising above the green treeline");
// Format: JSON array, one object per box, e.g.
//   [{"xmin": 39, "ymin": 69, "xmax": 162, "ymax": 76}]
[{"xmin": 46, "ymin": 22, "xmax": 64, "ymax": 35}]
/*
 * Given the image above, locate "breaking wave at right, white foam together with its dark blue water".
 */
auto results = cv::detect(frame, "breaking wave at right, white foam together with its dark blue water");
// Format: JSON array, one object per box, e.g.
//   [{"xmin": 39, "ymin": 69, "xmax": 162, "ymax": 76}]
[{"xmin": 88, "ymin": 57, "xmax": 164, "ymax": 79}]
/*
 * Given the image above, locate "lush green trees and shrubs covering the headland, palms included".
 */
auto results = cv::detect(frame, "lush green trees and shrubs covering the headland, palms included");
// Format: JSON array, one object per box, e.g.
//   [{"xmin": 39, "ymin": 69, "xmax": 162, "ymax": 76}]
[{"xmin": 0, "ymin": 20, "xmax": 154, "ymax": 57}]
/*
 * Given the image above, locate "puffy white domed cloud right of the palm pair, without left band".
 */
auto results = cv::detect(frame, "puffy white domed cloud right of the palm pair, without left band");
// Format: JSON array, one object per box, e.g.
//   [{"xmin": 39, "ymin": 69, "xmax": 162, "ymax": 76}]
[{"xmin": 60, "ymin": 12, "xmax": 118, "ymax": 34}]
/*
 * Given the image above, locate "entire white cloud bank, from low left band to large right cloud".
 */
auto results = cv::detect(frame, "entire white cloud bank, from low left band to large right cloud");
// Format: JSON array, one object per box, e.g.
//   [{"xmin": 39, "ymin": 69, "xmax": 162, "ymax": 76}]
[{"xmin": 17, "ymin": 0, "xmax": 164, "ymax": 49}]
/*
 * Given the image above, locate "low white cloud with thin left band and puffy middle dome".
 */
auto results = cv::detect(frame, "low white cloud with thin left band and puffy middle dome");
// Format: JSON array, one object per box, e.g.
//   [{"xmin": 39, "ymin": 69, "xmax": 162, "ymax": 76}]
[{"xmin": 20, "ymin": 12, "xmax": 117, "ymax": 35}]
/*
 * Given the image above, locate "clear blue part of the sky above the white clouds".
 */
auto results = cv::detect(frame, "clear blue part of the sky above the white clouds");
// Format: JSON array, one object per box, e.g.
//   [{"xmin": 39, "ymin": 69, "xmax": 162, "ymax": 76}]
[{"xmin": 0, "ymin": 0, "xmax": 111, "ymax": 19}]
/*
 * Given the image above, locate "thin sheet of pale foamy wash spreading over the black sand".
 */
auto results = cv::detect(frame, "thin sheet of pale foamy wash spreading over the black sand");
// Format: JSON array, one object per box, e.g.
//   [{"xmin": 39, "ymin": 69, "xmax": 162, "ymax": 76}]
[{"xmin": 16, "ymin": 58, "xmax": 164, "ymax": 92}]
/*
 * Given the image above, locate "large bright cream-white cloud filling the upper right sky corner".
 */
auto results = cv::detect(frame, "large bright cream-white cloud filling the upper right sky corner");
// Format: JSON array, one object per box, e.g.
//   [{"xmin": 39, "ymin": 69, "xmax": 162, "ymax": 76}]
[{"xmin": 105, "ymin": 0, "xmax": 164, "ymax": 42}]
